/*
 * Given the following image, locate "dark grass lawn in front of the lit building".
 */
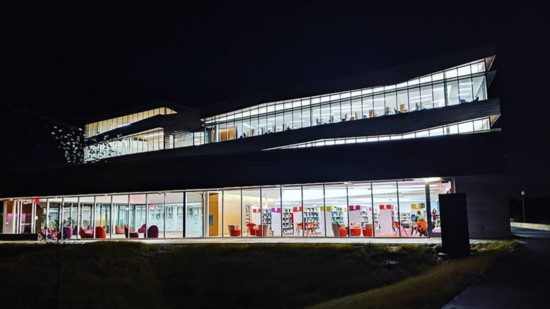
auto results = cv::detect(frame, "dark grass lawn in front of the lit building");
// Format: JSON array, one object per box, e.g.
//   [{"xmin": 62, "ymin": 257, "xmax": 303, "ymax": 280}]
[{"xmin": 0, "ymin": 242, "xmax": 512, "ymax": 308}]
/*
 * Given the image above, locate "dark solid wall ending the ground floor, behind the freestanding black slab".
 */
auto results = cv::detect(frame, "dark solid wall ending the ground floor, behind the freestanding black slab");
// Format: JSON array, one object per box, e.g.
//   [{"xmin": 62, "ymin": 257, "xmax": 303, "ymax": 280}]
[{"xmin": 455, "ymin": 175, "xmax": 511, "ymax": 239}]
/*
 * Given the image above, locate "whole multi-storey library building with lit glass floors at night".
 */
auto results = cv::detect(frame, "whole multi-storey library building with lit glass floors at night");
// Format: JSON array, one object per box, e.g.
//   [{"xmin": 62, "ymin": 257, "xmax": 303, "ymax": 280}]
[{"xmin": 0, "ymin": 49, "xmax": 510, "ymax": 240}]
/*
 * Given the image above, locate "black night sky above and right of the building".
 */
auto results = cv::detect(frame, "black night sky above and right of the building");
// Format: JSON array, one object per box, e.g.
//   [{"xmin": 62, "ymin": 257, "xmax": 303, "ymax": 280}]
[{"xmin": 0, "ymin": 1, "xmax": 550, "ymax": 196}]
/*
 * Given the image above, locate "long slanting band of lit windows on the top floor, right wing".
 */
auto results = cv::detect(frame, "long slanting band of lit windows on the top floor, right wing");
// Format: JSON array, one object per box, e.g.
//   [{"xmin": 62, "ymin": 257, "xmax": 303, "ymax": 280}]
[{"xmin": 206, "ymin": 60, "xmax": 487, "ymax": 143}]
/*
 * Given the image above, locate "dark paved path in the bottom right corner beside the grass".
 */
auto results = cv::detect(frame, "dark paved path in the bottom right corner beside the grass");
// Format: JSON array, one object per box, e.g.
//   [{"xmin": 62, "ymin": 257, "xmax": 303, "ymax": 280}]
[{"xmin": 443, "ymin": 228, "xmax": 550, "ymax": 309}]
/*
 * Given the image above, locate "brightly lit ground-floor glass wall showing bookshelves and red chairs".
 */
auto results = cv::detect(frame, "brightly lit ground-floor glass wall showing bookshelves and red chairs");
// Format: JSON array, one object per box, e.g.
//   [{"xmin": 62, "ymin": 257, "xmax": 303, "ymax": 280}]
[{"xmin": 1, "ymin": 178, "xmax": 453, "ymax": 239}]
